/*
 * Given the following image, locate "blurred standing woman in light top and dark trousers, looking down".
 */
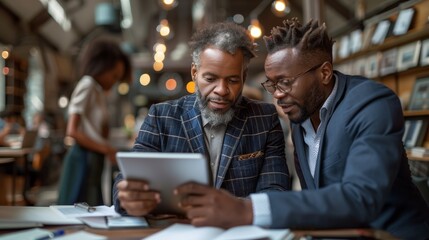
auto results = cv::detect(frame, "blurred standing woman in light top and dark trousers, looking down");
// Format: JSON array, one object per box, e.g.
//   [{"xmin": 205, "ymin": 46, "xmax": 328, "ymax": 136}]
[{"xmin": 58, "ymin": 39, "xmax": 131, "ymax": 205}]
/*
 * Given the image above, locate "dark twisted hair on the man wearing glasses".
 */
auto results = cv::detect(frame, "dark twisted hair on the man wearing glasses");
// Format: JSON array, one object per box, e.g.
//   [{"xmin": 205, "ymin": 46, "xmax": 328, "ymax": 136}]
[{"xmin": 264, "ymin": 18, "xmax": 335, "ymax": 62}]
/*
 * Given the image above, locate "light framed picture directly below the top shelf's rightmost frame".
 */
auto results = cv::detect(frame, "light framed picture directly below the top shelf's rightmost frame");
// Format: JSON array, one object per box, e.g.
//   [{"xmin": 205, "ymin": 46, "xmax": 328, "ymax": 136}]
[{"xmin": 397, "ymin": 41, "xmax": 421, "ymax": 71}]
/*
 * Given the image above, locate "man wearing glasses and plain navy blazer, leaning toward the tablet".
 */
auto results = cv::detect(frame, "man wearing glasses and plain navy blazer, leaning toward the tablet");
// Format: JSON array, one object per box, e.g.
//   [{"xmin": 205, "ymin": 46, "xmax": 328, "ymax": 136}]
[{"xmin": 176, "ymin": 18, "xmax": 429, "ymax": 239}]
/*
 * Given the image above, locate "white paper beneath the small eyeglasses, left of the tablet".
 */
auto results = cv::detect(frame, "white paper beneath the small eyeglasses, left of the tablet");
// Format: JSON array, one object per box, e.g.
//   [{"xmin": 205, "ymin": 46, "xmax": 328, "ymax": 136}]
[{"xmin": 50, "ymin": 205, "xmax": 120, "ymax": 218}]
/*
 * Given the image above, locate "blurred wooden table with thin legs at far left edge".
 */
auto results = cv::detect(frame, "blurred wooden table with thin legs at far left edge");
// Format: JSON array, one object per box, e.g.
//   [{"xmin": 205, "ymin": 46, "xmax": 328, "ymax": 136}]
[{"xmin": 0, "ymin": 147, "xmax": 34, "ymax": 205}]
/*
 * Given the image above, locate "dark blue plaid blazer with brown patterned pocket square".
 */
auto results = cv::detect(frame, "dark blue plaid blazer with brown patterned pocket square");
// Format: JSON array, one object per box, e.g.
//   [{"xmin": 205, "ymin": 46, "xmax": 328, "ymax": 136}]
[{"xmin": 113, "ymin": 94, "xmax": 290, "ymax": 207}]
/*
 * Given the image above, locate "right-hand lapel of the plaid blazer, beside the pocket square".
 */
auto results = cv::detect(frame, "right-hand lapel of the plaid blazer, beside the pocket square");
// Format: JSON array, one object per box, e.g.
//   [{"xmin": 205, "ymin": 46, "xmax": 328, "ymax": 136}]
[{"xmin": 215, "ymin": 105, "xmax": 248, "ymax": 188}]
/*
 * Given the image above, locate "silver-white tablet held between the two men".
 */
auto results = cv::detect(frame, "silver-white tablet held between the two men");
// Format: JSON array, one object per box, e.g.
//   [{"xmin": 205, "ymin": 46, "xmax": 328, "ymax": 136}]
[{"xmin": 116, "ymin": 152, "xmax": 211, "ymax": 214}]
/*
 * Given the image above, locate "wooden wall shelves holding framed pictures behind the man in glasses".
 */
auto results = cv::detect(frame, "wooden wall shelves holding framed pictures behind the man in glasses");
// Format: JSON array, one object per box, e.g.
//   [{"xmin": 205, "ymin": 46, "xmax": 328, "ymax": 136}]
[{"xmin": 334, "ymin": 0, "xmax": 429, "ymax": 154}]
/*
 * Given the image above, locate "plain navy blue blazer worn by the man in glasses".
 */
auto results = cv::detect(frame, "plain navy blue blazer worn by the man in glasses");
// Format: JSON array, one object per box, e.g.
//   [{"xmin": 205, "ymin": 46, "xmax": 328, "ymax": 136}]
[{"xmin": 268, "ymin": 72, "xmax": 429, "ymax": 239}]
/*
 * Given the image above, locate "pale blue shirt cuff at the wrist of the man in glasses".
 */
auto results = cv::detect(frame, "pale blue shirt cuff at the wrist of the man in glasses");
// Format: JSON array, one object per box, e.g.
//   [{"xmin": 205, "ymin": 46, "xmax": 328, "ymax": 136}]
[{"xmin": 250, "ymin": 193, "xmax": 271, "ymax": 227}]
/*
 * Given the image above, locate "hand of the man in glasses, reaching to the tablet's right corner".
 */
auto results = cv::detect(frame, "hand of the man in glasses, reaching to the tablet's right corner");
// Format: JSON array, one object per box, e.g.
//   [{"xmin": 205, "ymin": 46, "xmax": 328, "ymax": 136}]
[{"xmin": 174, "ymin": 183, "xmax": 253, "ymax": 228}]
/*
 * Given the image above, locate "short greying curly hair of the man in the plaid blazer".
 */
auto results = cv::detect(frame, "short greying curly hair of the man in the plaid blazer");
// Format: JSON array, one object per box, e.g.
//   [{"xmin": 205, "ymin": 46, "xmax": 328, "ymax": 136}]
[{"xmin": 189, "ymin": 22, "xmax": 256, "ymax": 67}]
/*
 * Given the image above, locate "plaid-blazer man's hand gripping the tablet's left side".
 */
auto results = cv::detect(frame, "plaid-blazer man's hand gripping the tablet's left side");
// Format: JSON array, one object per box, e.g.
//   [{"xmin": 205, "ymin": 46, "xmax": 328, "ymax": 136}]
[{"xmin": 116, "ymin": 180, "xmax": 161, "ymax": 216}]
